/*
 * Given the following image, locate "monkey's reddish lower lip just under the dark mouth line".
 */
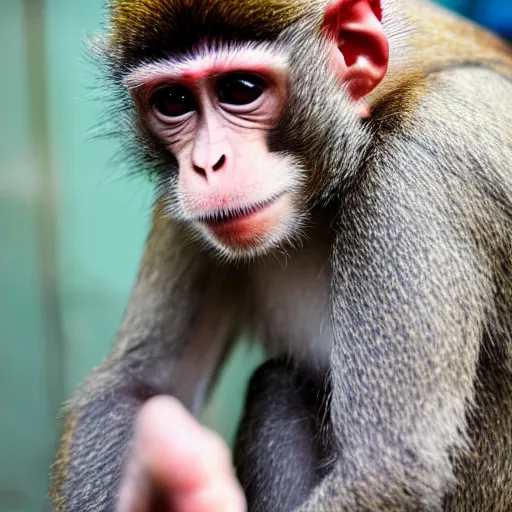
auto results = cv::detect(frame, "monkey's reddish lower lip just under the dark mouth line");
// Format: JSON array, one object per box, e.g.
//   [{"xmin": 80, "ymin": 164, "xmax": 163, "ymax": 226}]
[{"xmin": 202, "ymin": 193, "xmax": 286, "ymax": 247}]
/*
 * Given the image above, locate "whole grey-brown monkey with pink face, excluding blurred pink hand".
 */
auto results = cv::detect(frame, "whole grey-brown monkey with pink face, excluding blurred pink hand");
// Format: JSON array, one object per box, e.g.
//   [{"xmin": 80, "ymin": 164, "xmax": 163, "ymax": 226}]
[{"xmin": 52, "ymin": 0, "xmax": 512, "ymax": 512}]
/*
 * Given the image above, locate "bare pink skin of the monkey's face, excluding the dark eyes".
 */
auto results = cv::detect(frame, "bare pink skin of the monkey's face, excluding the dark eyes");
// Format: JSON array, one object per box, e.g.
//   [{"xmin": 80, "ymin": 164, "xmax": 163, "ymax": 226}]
[{"xmin": 128, "ymin": 49, "xmax": 290, "ymax": 247}]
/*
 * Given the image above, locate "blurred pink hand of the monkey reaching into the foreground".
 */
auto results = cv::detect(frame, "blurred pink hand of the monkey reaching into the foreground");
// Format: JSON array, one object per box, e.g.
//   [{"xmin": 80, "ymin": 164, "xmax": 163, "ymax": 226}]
[{"xmin": 117, "ymin": 396, "xmax": 246, "ymax": 512}]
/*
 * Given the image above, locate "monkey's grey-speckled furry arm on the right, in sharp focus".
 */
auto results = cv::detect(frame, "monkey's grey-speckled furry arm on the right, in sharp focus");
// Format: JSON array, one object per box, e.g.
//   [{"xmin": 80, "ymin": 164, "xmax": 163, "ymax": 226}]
[{"xmin": 301, "ymin": 137, "xmax": 493, "ymax": 512}]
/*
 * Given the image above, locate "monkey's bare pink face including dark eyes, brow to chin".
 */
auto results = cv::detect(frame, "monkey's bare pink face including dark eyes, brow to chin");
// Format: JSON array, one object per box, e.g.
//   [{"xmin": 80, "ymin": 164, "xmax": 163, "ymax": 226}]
[{"xmin": 126, "ymin": 46, "xmax": 305, "ymax": 257}]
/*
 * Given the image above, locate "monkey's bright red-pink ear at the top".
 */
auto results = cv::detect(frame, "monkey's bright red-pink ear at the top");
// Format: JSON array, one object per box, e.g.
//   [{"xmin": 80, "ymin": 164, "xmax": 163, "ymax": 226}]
[{"xmin": 324, "ymin": 0, "xmax": 389, "ymax": 101}]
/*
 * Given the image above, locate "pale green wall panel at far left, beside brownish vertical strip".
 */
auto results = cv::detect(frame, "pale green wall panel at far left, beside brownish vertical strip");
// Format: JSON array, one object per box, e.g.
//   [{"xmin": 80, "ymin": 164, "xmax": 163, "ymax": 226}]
[{"xmin": 0, "ymin": 0, "xmax": 55, "ymax": 512}]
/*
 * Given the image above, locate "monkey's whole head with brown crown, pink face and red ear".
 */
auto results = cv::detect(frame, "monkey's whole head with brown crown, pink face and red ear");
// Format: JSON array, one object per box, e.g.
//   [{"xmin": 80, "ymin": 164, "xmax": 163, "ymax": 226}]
[{"xmin": 106, "ymin": 0, "xmax": 389, "ymax": 257}]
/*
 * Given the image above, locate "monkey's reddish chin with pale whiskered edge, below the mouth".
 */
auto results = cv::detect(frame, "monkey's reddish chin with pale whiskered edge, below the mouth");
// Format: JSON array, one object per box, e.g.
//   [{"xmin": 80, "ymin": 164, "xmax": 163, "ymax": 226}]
[{"xmin": 203, "ymin": 194, "xmax": 291, "ymax": 258}]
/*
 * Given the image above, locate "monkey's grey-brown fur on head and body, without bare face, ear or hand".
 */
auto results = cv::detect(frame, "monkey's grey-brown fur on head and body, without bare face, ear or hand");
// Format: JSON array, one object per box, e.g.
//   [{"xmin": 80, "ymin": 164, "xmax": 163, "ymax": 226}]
[{"xmin": 53, "ymin": 0, "xmax": 512, "ymax": 512}]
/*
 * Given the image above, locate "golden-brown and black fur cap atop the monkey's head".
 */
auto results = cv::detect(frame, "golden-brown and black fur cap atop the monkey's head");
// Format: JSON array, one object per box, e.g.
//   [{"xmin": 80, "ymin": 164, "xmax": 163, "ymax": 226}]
[{"xmin": 107, "ymin": 0, "xmax": 323, "ymax": 64}]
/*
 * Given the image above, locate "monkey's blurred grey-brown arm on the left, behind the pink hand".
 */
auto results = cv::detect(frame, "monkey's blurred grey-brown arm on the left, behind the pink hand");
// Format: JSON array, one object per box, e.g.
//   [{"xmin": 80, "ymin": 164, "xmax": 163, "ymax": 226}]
[{"xmin": 52, "ymin": 204, "xmax": 234, "ymax": 512}]
